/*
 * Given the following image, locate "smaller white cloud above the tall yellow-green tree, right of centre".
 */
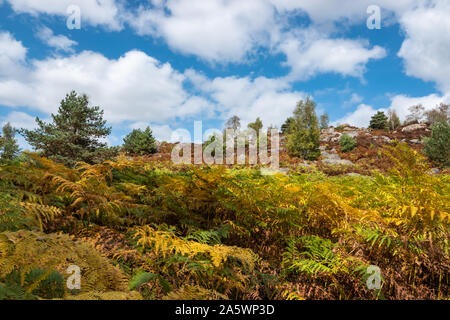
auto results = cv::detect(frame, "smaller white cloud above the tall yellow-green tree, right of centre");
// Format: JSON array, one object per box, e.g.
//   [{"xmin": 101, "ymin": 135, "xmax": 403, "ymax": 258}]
[{"xmin": 279, "ymin": 32, "xmax": 386, "ymax": 80}]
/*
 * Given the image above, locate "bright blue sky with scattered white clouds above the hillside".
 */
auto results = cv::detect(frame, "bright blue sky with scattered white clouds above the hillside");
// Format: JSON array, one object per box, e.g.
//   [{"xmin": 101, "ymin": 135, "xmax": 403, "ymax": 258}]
[{"xmin": 0, "ymin": 0, "xmax": 450, "ymax": 148}]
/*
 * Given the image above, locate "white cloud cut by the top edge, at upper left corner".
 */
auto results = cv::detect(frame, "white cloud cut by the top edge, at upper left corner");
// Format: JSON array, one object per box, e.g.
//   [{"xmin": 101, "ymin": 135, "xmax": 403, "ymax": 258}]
[{"xmin": 7, "ymin": 0, "xmax": 123, "ymax": 30}]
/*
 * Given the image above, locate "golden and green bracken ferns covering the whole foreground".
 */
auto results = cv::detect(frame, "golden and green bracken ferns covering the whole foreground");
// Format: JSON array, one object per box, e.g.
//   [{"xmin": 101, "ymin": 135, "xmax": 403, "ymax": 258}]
[{"xmin": 0, "ymin": 144, "xmax": 450, "ymax": 299}]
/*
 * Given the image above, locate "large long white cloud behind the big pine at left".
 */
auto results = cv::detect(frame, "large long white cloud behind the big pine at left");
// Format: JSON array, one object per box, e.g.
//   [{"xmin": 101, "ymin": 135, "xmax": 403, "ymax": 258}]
[{"xmin": 0, "ymin": 51, "xmax": 211, "ymax": 123}]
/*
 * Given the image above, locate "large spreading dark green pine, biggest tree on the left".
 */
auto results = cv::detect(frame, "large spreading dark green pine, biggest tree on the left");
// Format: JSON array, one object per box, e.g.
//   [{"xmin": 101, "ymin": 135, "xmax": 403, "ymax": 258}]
[{"xmin": 19, "ymin": 91, "xmax": 115, "ymax": 166}]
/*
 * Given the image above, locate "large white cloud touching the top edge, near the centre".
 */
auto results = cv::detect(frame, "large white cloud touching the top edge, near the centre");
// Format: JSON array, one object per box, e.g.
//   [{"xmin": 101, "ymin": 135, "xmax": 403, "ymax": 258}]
[{"xmin": 129, "ymin": 0, "xmax": 275, "ymax": 62}]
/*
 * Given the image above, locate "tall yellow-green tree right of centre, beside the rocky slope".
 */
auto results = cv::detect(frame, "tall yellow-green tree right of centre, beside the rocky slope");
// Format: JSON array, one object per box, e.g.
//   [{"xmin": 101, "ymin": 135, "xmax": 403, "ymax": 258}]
[{"xmin": 287, "ymin": 97, "xmax": 320, "ymax": 160}]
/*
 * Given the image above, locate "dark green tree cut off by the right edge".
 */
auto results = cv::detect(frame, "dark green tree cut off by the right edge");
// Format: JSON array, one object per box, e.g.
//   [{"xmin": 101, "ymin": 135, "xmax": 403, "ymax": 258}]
[{"xmin": 423, "ymin": 121, "xmax": 450, "ymax": 167}]
